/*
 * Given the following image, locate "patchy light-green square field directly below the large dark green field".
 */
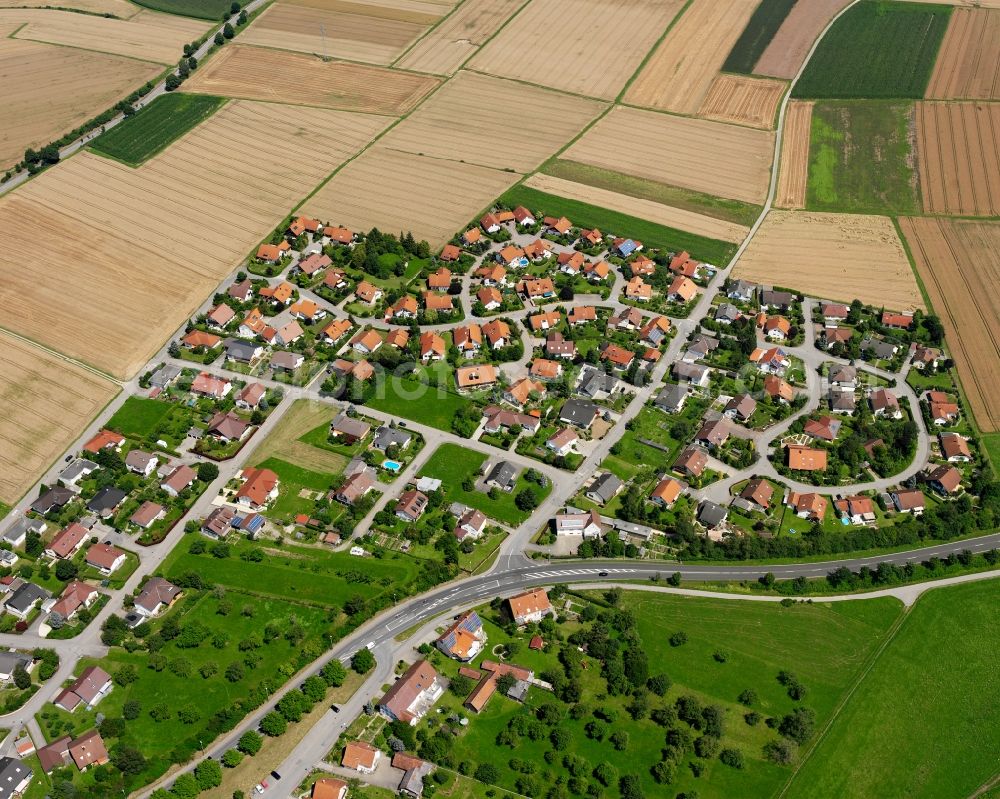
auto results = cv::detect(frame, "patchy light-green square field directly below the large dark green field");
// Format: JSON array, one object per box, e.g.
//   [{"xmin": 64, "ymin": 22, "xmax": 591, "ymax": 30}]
[{"xmin": 806, "ymin": 102, "xmax": 921, "ymax": 213}]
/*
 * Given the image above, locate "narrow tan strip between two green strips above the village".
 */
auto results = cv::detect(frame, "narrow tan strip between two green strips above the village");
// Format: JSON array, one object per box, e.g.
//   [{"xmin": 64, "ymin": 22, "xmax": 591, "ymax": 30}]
[{"xmin": 524, "ymin": 173, "xmax": 750, "ymax": 243}]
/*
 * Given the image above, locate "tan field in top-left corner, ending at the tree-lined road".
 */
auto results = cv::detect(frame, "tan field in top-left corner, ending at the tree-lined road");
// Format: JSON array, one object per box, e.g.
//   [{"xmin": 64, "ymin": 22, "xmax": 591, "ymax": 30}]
[{"xmin": 0, "ymin": 9, "xmax": 209, "ymax": 64}]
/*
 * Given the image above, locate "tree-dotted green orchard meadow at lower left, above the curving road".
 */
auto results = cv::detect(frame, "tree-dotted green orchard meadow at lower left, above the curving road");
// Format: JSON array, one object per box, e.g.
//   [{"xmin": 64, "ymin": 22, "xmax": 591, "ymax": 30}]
[{"xmin": 38, "ymin": 591, "xmax": 329, "ymax": 795}]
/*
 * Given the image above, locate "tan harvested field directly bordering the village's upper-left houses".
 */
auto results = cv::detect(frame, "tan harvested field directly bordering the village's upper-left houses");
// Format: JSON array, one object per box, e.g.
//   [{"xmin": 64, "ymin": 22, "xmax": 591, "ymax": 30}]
[{"xmin": 303, "ymin": 146, "xmax": 518, "ymax": 249}]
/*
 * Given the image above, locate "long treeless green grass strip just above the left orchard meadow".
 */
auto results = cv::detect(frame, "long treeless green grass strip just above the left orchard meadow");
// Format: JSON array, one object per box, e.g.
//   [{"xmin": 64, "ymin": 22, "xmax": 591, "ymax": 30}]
[{"xmin": 161, "ymin": 537, "xmax": 417, "ymax": 607}]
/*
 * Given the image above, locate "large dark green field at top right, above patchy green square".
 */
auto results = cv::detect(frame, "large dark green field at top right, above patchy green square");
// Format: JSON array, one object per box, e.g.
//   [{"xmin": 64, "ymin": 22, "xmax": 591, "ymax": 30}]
[{"xmin": 793, "ymin": 0, "xmax": 951, "ymax": 99}]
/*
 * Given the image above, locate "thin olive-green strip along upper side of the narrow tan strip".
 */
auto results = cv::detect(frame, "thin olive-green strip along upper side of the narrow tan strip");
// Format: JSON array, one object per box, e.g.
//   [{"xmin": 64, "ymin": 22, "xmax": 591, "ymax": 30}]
[{"xmin": 542, "ymin": 159, "xmax": 761, "ymax": 225}]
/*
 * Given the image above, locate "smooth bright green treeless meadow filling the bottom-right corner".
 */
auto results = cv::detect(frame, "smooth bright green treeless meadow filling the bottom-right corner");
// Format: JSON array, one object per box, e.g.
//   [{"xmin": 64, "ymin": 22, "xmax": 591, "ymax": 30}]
[{"xmin": 787, "ymin": 580, "xmax": 1000, "ymax": 799}]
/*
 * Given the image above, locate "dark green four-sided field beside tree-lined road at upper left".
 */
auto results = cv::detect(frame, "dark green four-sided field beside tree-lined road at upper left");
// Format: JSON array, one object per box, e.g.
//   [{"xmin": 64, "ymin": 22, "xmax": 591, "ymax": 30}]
[{"xmin": 90, "ymin": 92, "xmax": 226, "ymax": 166}]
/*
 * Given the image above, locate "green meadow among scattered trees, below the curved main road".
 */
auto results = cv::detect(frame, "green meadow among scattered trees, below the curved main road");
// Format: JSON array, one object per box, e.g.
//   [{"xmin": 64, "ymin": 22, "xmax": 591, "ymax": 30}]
[{"xmin": 412, "ymin": 593, "xmax": 900, "ymax": 799}]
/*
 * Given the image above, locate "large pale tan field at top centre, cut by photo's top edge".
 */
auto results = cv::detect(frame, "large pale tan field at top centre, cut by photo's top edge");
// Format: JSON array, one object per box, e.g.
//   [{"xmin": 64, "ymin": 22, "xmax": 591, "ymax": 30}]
[{"xmin": 469, "ymin": 0, "xmax": 684, "ymax": 100}]
